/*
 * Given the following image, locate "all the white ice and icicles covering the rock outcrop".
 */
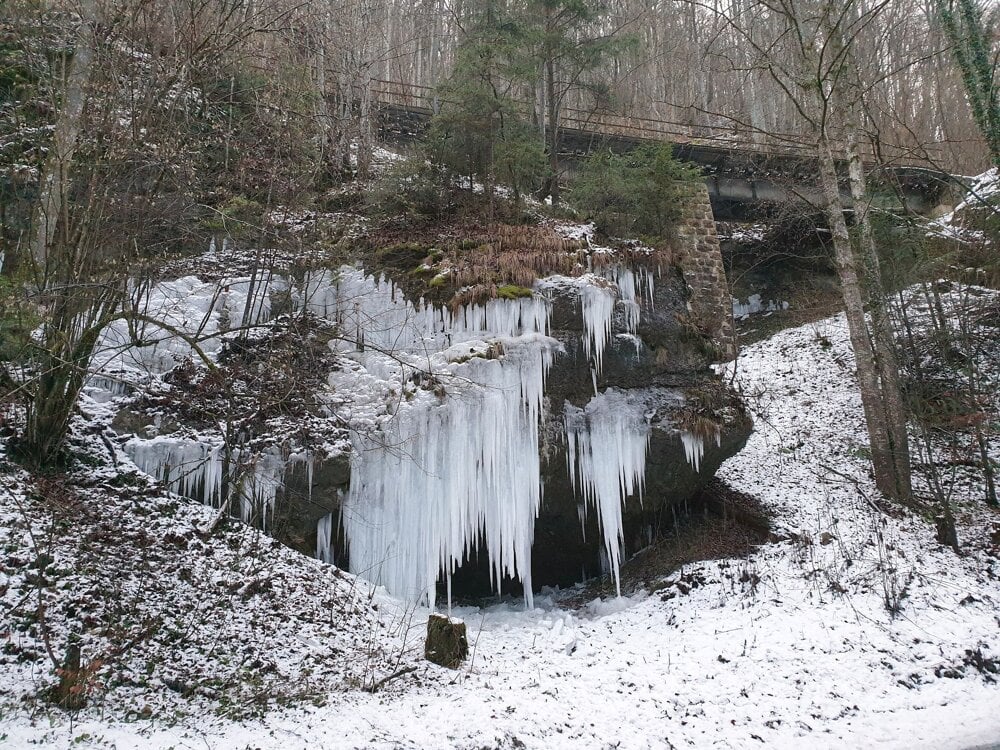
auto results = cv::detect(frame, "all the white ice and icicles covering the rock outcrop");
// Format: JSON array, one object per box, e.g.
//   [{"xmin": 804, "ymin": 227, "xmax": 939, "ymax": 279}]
[{"xmin": 105, "ymin": 258, "xmax": 668, "ymax": 606}]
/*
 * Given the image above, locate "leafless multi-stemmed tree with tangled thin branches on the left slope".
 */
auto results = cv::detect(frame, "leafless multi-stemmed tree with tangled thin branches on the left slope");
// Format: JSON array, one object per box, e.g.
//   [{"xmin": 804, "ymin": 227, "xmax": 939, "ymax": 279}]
[{"xmin": 4, "ymin": 0, "xmax": 328, "ymax": 465}]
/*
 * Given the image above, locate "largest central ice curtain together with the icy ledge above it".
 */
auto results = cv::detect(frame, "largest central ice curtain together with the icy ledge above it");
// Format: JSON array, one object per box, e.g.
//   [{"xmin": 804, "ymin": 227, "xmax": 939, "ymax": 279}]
[{"xmin": 305, "ymin": 269, "xmax": 558, "ymax": 605}]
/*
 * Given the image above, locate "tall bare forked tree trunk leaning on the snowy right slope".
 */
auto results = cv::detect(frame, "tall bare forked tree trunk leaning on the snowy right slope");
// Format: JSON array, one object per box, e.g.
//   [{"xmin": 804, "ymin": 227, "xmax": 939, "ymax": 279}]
[{"xmin": 696, "ymin": 0, "xmax": 912, "ymax": 503}]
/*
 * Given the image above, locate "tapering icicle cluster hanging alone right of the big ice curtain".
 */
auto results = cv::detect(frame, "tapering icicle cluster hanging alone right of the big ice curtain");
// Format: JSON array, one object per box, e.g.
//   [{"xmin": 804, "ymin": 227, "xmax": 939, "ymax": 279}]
[{"xmin": 564, "ymin": 388, "xmax": 650, "ymax": 595}]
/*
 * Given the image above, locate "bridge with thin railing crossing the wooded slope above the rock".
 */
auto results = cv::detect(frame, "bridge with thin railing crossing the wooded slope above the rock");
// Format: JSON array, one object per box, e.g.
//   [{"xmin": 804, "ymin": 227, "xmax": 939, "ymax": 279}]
[{"xmin": 373, "ymin": 80, "xmax": 955, "ymax": 221}]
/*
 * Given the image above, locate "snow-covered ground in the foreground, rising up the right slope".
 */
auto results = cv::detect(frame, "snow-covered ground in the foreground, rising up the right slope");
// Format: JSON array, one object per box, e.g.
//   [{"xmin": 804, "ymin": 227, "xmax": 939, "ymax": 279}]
[{"xmin": 0, "ymin": 298, "xmax": 1000, "ymax": 749}]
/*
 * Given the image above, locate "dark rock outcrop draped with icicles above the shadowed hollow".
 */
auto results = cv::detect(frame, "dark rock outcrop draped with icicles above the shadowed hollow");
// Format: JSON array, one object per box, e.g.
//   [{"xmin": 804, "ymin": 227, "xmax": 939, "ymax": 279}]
[{"xmin": 107, "ymin": 264, "xmax": 751, "ymax": 604}]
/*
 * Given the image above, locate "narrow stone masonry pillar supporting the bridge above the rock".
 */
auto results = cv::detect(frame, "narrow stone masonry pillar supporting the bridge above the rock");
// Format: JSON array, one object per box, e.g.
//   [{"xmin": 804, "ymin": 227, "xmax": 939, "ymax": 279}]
[{"xmin": 677, "ymin": 184, "xmax": 736, "ymax": 359}]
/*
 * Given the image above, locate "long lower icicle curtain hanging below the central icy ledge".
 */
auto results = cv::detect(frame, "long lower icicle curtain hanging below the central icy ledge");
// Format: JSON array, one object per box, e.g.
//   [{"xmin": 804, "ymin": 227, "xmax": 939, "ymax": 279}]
[{"xmin": 344, "ymin": 344, "xmax": 552, "ymax": 606}]
